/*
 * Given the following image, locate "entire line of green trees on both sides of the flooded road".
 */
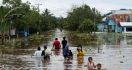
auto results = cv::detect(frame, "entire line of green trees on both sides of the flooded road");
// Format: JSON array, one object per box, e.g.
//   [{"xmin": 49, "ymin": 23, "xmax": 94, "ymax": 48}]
[{"xmin": 0, "ymin": 0, "xmax": 102, "ymax": 33}]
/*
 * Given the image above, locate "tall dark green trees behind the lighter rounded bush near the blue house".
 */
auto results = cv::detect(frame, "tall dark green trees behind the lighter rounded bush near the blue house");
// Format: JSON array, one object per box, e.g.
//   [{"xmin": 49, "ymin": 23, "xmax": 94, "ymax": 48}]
[{"xmin": 60, "ymin": 5, "xmax": 102, "ymax": 31}]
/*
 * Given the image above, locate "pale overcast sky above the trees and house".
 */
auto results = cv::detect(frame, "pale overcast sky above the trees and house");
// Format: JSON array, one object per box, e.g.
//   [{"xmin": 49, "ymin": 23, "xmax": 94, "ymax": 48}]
[{"xmin": 0, "ymin": 0, "xmax": 132, "ymax": 17}]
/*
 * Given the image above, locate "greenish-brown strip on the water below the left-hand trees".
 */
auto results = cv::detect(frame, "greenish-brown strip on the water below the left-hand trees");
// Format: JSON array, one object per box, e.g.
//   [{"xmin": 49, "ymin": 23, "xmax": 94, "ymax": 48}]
[{"xmin": 0, "ymin": 30, "xmax": 53, "ymax": 49}]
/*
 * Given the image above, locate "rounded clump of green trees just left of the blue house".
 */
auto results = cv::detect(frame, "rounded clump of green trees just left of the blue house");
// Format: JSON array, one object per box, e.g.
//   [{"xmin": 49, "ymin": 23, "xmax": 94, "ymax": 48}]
[{"xmin": 59, "ymin": 5, "xmax": 102, "ymax": 33}]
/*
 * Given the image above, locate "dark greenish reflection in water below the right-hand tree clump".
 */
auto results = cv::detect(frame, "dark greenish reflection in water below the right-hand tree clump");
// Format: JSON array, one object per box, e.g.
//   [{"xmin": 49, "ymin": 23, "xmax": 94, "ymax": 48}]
[{"xmin": 67, "ymin": 32, "xmax": 98, "ymax": 46}]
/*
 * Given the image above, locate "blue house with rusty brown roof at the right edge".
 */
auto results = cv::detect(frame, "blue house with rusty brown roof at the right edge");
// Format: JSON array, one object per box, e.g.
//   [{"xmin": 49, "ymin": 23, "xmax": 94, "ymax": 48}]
[{"xmin": 104, "ymin": 9, "xmax": 132, "ymax": 32}]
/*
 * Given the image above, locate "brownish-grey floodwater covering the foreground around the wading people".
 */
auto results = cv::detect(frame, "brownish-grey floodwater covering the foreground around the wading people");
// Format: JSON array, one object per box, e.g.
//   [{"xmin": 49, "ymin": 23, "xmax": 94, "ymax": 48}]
[{"xmin": 0, "ymin": 29, "xmax": 132, "ymax": 70}]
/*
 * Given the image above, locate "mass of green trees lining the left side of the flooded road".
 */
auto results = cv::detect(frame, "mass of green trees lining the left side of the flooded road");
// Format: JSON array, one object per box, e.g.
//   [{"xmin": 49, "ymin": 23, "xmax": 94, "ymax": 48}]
[{"xmin": 0, "ymin": 0, "xmax": 57, "ymax": 45}]
